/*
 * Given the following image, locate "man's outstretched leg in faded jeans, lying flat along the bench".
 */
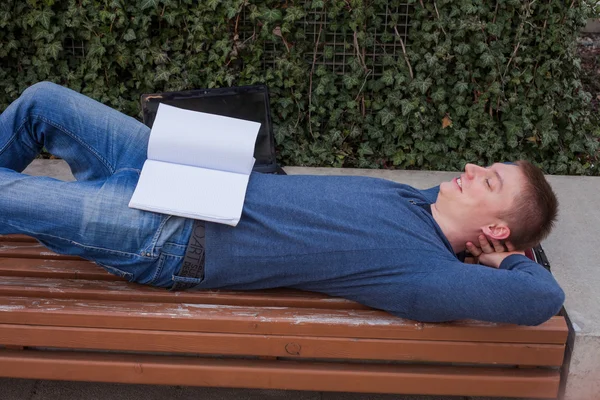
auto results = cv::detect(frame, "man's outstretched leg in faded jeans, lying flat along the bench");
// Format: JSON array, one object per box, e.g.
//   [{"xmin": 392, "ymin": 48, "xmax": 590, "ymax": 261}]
[{"xmin": 0, "ymin": 168, "xmax": 178, "ymax": 278}]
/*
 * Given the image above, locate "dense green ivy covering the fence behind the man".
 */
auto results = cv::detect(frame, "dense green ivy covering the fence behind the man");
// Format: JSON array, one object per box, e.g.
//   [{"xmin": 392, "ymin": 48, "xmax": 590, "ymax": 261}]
[{"xmin": 0, "ymin": 0, "xmax": 599, "ymax": 174}]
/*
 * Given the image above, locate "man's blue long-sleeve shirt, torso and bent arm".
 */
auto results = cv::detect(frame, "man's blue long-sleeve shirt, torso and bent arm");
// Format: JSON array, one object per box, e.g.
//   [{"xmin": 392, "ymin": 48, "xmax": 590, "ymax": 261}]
[{"xmin": 198, "ymin": 174, "xmax": 564, "ymax": 325}]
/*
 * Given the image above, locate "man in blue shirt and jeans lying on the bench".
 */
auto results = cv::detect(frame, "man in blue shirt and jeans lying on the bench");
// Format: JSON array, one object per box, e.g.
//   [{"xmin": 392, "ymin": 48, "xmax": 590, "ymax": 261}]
[{"xmin": 0, "ymin": 83, "xmax": 564, "ymax": 325}]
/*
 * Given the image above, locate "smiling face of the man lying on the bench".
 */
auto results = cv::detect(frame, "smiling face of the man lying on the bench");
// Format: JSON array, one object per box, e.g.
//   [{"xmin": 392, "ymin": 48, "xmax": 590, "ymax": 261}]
[{"xmin": 436, "ymin": 163, "xmax": 525, "ymax": 234}]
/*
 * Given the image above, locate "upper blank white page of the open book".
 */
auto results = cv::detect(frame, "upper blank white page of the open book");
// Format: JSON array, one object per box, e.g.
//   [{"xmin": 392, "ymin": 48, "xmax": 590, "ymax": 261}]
[{"xmin": 148, "ymin": 104, "xmax": 260, "ymax": 174}]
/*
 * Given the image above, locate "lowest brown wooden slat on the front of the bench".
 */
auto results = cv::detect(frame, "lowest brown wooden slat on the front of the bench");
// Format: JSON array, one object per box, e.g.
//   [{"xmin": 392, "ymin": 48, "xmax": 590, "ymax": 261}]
[{"xmin": 0, "ymin": 350, "xmax": 560, "ymax": 398}]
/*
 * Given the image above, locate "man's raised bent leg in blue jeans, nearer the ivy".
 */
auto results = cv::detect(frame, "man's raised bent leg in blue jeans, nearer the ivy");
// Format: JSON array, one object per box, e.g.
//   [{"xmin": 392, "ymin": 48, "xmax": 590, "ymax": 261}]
[{"xmin": 0, "ymin": 82, "xmax": 150, "ymax": 180}]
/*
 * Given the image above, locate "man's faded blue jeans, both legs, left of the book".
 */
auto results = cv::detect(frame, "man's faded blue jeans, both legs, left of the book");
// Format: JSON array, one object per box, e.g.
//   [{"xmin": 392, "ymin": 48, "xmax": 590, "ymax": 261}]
[{"xmin": 0, "ymin": 82, "xmax": 192, "ymax": 287}]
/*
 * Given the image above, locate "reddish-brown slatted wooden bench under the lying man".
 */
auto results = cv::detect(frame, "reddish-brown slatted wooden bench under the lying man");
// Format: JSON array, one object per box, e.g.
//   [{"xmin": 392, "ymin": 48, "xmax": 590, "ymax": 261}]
[{"xmin": 0, "ymin": 236, "xmax": 568, "ymax": 398}]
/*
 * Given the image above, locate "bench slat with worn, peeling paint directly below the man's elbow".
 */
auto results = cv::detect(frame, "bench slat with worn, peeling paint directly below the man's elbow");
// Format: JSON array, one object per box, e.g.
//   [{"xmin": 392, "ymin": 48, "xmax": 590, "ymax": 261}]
[{"xmin": 0, "ymin": 297, "xmax": 568, "ymax": 344}]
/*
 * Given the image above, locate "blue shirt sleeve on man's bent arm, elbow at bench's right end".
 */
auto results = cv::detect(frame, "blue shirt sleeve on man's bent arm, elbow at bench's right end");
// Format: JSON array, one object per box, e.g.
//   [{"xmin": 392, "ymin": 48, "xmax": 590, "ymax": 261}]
[{"xmin": 410, "ymin": 254, "xmax": 565, "ymax": 325}]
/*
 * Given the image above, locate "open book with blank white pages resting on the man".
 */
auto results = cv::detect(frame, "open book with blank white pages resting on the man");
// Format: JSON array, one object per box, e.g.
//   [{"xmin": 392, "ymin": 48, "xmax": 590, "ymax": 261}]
[{"xmin": 129, "ymin": 104, "xmax": 260, "ymax": 226}]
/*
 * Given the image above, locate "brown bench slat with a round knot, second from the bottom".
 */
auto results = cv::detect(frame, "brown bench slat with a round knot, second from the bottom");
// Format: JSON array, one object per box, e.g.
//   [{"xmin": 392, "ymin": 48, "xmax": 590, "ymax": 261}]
[{"xmin": 0, "ymin": 324, "xmax": 564, "ymax": 366}]
